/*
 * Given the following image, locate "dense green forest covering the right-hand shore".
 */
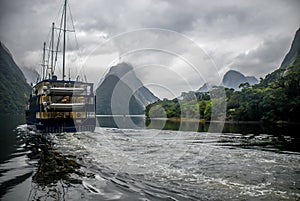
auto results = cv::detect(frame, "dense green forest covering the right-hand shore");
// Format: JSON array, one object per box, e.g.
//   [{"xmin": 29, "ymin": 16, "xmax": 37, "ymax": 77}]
[{"xmin": 145, "ymin": 30, "xmax": 300, "ymax": 122}]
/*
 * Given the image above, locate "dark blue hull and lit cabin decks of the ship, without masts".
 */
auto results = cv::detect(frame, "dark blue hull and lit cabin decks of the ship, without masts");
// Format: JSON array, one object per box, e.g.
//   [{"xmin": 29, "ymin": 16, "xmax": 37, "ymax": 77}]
[{"xmin": 26, "ymin": 76, "xmax": 96, "ymax": 133}]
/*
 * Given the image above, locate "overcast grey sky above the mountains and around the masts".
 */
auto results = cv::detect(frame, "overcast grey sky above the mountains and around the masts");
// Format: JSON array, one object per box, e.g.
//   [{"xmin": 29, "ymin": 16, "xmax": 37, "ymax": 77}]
[{"xmin": 0, "ymin": 0, "xmax": 300, "ymax": 98}]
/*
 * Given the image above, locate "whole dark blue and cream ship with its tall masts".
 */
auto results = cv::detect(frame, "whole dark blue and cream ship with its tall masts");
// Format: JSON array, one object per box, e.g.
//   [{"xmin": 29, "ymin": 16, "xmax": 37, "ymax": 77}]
[{"xmin": 25, "ymin": 0, "xmax": 96, "ymax": 133}]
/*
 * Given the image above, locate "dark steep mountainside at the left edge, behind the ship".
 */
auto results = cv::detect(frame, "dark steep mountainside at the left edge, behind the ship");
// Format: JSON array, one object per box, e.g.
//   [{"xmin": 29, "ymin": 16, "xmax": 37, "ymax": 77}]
[{"xmin": 0, "ymin": 42, "xmax": 31, "ymax": 114}]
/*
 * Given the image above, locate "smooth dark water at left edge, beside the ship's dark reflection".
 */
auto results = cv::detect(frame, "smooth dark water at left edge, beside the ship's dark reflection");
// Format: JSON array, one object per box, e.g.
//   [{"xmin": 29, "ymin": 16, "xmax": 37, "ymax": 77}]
[{"xmin": 0, "ymin": 115, "xmax": 33, "ymax": 198}]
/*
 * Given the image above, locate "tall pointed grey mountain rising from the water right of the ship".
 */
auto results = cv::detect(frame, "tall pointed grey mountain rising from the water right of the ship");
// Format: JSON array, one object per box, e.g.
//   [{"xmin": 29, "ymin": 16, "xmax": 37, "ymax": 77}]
[{"xmin": 96, "ymin": 63, "xmax": 159, "ymax": 115}]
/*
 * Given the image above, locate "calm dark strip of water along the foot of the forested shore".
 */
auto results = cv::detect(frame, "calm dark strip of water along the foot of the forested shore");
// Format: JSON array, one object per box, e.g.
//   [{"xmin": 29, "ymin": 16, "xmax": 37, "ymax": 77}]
[{"xmin": 97, "ymin": 116, "xmax": 299, "ymax": 135}]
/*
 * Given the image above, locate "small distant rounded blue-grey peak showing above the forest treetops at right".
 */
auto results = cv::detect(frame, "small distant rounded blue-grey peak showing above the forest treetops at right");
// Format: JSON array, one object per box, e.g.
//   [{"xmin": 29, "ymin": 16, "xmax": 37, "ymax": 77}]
[{"xmin": 222, "ymin": 70, "xmax": 258, "ymax": 90}]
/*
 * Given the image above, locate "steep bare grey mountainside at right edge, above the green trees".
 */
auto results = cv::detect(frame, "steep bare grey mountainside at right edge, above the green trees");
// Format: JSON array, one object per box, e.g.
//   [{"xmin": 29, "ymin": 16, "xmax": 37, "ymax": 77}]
[{"xmin": 280, "ymin": 28, "xmax": 300, "ymax": 69}]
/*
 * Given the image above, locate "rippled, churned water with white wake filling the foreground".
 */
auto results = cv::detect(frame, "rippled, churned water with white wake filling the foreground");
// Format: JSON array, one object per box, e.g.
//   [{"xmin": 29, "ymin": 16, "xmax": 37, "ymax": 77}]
[{"xmin": 0, "ymin": 115, "xmax": 300, "ymax": 200}]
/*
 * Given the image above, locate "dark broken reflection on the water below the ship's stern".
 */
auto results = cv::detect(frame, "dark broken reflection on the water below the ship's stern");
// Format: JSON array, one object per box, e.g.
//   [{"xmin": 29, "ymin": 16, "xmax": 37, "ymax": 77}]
[{"xmin": 27, "ymin": 134, "xmax": 82, "ymax": 200}]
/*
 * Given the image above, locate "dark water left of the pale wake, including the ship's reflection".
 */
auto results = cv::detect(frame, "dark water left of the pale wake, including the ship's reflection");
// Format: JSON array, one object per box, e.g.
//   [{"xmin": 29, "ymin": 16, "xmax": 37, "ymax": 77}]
[{"xmin": 0, "ymin": 115, "xmax": 81, "ymax": 200}]
